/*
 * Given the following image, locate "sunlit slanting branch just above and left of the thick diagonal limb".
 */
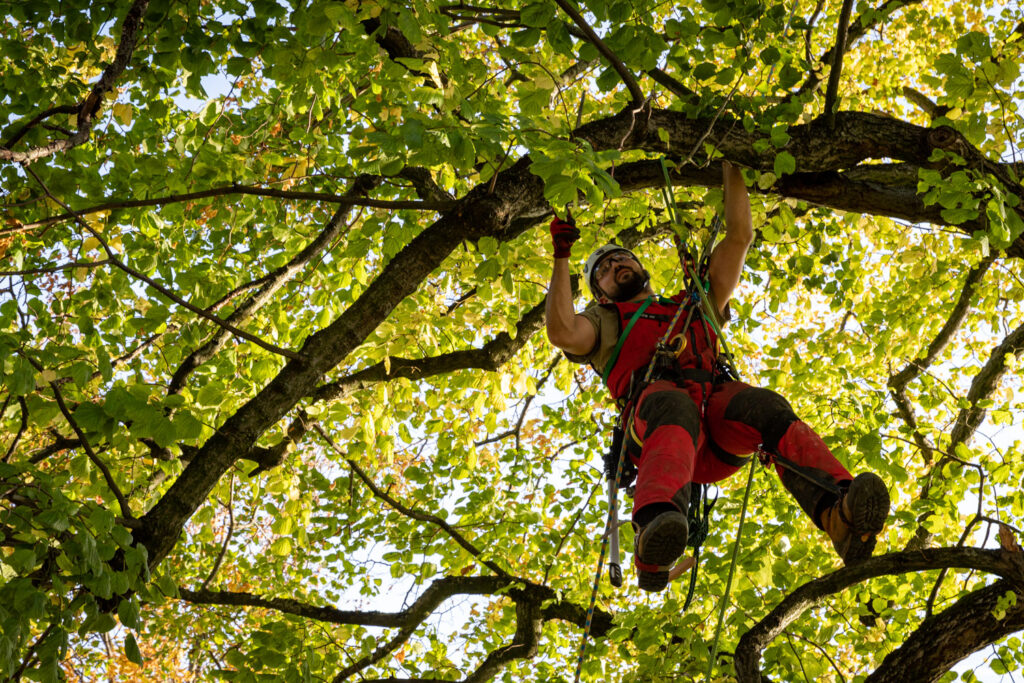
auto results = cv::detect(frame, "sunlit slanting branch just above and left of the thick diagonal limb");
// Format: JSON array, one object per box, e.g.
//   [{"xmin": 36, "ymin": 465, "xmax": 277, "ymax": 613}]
[{"xmin": 167, "ymin": 176, "xmax": 380, "ymax": 394}]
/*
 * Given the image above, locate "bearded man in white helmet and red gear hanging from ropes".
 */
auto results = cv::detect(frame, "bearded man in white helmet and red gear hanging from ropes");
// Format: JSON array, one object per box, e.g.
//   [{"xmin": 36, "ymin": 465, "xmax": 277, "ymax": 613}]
[{"xmin": 547, "ymin": 162, "xmax": 890, "ymax": 591}]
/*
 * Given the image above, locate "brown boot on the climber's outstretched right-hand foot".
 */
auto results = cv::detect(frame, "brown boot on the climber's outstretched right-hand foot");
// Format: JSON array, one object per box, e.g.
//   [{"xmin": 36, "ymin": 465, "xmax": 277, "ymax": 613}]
[{"xmin": 821, "ymin": 472, "xmax": 890, "ymax": 566}]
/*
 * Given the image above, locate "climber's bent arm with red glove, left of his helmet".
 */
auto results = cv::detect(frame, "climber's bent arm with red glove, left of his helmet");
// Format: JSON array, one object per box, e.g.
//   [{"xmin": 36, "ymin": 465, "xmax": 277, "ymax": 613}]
[{"xmin": 546, "ymin": 218, "xmax": 597, "ymax": 355}]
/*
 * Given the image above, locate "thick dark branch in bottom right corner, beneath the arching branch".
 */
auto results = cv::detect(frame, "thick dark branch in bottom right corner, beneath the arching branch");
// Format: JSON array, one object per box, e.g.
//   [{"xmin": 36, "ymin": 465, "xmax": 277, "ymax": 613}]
[{"xmin": 864, "ymin": 579, "xmax": 1024, "ymax": 683}]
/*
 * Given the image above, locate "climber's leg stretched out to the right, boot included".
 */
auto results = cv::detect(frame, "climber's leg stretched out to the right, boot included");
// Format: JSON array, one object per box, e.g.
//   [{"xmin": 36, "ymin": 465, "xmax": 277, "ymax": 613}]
[{"xmin": 707, "ymin": 382, "xmax": 889, "ymax": 564}]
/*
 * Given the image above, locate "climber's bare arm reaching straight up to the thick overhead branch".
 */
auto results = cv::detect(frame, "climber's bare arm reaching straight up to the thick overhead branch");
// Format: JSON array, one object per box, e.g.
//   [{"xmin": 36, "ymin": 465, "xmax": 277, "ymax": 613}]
[{"xmin": 708, "ymin": 160, "xmax": 754, "ymax": 315}]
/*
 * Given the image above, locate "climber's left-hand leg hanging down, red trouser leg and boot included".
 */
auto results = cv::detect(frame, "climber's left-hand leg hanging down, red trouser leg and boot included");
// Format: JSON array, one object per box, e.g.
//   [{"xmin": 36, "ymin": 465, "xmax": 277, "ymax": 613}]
[{"xmin": 627, "ymin": 381, "xmax": 702, "ymax": 591}]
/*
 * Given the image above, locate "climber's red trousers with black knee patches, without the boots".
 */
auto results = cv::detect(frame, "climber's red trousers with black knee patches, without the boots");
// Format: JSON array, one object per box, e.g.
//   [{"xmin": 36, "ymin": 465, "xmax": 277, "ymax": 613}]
[{"xmin": 628, "ymin": 380, "xmax": 853, "ymax": 525}]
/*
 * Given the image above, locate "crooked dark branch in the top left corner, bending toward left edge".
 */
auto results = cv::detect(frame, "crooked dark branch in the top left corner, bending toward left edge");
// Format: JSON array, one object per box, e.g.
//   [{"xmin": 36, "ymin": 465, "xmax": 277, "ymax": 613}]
[{"xmin": 0, "ymin": 0, "xmax": 150, "ymax": 164}]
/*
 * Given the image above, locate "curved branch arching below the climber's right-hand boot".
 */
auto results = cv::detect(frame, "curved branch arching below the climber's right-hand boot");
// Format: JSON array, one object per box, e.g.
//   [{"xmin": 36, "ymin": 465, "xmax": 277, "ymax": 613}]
[{"xmin": 734, "ymin": 548, "xmax": 1024, "ymax": 683}]
